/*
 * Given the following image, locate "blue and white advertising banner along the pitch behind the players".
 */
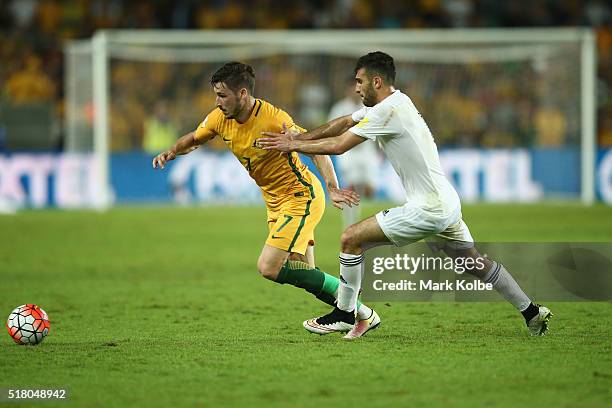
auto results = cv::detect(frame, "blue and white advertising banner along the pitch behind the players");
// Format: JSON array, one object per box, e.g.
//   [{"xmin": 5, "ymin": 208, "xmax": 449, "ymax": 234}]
[{"xmin": 0, "ymin": 148, "xmax": 612, "ymax": 211}]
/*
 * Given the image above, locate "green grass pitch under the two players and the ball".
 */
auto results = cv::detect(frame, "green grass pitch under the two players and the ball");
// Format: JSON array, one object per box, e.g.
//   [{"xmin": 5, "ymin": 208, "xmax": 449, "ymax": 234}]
[{"xmin": 0, "ymin": 205, "xmax": 612, "ymax": 407}]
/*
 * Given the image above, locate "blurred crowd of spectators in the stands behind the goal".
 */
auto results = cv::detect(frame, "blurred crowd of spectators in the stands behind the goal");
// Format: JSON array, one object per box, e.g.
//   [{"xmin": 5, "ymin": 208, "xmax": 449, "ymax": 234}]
[{"xmin": 0, "ymin": 0, "xmax": 612, "ymax": 151}]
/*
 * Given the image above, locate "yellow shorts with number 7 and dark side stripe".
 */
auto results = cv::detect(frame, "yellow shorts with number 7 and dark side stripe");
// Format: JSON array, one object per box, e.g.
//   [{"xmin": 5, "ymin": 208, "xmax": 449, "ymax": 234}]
[{"xmin": 266, "ymin": 177, "xmax": 325, "ymax": 255}]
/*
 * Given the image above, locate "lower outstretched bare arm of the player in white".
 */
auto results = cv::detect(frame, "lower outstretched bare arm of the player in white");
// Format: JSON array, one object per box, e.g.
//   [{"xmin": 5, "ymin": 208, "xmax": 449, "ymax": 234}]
[{"xmin": 258, "ymin": 131, "xmax": 365, "ymax": 155}]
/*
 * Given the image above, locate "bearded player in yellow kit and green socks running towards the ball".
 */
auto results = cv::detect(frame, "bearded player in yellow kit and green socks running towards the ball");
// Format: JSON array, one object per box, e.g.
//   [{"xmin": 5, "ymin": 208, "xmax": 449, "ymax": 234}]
[{"xmin": 153, "ymin": 62, "xmax": 379, "ymax": 334}]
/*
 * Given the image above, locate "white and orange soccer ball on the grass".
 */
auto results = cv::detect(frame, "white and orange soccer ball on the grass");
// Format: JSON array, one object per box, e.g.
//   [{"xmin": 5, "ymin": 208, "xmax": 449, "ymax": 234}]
[{"xmin": 6, "ymin": 304, "xmax": 51, "ymax": 344}]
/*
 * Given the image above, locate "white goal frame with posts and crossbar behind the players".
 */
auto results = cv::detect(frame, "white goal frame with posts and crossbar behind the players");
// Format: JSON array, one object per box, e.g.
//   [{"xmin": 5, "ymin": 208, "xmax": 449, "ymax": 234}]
[{"xmin": 66, "ymin": 28, "xmax": 596, "ymax": 205}]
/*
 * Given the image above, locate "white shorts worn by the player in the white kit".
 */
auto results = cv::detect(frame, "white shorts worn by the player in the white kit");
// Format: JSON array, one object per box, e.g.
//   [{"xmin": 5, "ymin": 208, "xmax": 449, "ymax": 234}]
[{"xmin": 376, "ymin": 203, "xmax": 474, "ymax": 249}]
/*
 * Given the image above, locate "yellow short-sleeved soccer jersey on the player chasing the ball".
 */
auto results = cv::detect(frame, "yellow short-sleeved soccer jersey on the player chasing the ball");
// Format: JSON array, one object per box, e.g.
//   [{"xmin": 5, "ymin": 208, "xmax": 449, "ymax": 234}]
[{"xmin": 195, "ymin": 99, "xmax": 315, "ymax": 210}]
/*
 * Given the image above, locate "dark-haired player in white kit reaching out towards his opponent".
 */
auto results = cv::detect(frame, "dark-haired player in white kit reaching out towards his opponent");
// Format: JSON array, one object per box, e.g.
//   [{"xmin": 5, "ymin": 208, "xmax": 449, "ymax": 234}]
[{"xmin": 259, "ymin": 51, "xmax": 552, "ymax": 339}]
